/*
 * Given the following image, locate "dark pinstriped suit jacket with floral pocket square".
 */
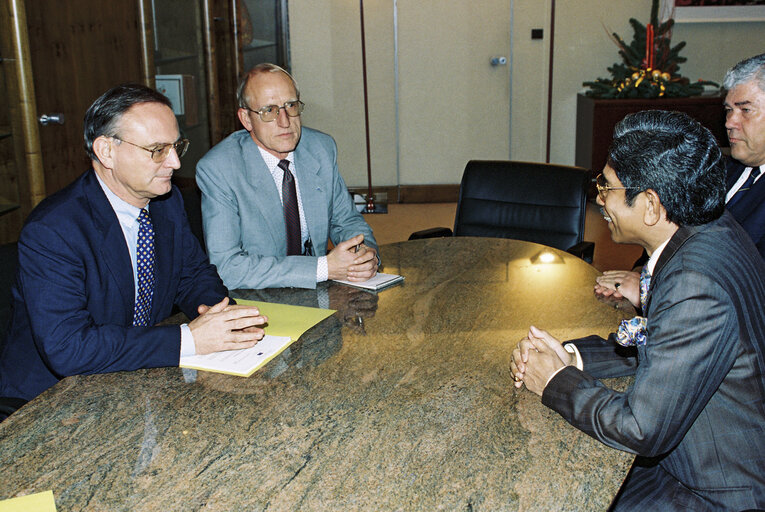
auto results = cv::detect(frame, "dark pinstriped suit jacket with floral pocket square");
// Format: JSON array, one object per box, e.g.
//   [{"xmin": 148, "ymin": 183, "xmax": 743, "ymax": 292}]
[{"xmin": 542, "ymin": 212, "xmax": 765, "ymax": 510}]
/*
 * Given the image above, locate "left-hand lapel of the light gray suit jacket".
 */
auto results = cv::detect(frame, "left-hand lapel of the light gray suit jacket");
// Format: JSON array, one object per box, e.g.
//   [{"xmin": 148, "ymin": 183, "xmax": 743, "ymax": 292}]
[{"xmin": 239, "ymin": 137, "xmax": 287, "ymax": 254}]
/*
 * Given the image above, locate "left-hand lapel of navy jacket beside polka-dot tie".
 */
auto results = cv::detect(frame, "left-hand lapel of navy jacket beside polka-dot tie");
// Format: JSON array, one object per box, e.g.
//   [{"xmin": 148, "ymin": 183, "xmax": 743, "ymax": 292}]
[{"xmin": 83, "ymin": 170, "xmax": 135, "ymax": 322}]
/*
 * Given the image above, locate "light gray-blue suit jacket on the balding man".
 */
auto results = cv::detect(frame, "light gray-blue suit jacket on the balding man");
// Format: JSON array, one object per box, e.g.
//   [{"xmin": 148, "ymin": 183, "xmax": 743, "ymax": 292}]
[{"xmin": 197, "ymin": 127, "xmax": 377, "ymax": 289}]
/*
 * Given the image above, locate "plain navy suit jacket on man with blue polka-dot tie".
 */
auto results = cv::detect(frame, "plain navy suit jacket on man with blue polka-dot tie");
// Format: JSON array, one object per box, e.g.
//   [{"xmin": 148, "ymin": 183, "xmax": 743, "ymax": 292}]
[{"xmin": 0, "ymin": 170, "xmax": 228, "ymax": 399}]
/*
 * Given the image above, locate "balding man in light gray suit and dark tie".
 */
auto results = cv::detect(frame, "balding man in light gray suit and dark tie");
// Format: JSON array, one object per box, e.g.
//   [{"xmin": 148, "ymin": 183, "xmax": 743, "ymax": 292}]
[{"xmin": 196, "ymin": 64, "xmax": 379, "ymax": 289}]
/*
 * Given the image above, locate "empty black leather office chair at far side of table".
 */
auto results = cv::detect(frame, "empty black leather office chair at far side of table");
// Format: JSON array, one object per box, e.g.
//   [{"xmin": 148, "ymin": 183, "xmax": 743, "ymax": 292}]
[{"xmin": 409, "ymin": 160, "xmax": 595, "ymax": 263}]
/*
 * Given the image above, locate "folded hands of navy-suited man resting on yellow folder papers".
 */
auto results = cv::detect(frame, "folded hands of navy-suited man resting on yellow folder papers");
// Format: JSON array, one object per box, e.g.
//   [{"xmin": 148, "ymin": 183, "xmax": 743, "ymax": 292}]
[{"xmin": 189, "ymin": 297, "xmax": 268, "ymax": 355}]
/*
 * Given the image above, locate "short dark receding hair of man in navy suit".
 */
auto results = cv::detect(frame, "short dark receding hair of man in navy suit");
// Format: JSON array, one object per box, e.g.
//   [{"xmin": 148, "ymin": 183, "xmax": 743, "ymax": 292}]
[{"xmin": 83, "ymin": 83, "xmax": 173, "ymax": 160}]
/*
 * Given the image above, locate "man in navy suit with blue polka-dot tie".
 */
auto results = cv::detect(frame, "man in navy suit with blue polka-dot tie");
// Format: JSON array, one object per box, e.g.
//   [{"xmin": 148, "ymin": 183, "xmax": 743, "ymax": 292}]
[{"xmin": 0, "ymin": 84, "xmax": 265, "ymax": 414}]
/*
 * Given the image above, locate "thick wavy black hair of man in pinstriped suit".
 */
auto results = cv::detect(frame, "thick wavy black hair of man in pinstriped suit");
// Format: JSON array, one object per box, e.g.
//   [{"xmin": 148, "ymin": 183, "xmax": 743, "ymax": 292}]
[{"xmin": 608, "ymin": 110, "xmax": 725, "ymax": 226}]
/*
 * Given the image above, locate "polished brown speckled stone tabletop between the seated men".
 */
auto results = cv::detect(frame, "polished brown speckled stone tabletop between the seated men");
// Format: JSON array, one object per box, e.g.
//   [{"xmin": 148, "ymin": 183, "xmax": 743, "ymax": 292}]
[{"xmin": 0, "ymin": 238, "xmax": 633, "ymax": 511}]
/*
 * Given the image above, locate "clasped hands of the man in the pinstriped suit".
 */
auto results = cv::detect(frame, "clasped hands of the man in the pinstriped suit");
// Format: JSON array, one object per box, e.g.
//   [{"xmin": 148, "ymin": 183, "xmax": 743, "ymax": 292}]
[{"xmin": 510, "ymin": 325, "xmax": 576, "ymax": 396}]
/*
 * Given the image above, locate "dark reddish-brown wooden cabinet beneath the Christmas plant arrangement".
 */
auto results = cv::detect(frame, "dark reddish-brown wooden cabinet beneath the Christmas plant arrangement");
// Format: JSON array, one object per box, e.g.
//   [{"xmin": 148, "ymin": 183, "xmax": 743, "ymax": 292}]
[{"xmin": 576, "ymin": 94, "xmax": 728, "ymax": 174}]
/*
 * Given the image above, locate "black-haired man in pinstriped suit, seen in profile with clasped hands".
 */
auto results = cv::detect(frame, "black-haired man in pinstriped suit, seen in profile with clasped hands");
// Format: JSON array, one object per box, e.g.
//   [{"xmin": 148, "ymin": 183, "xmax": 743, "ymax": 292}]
[{"xmin": 511, "ymin": 111, "xmax": 765, "ymax": 511}]
